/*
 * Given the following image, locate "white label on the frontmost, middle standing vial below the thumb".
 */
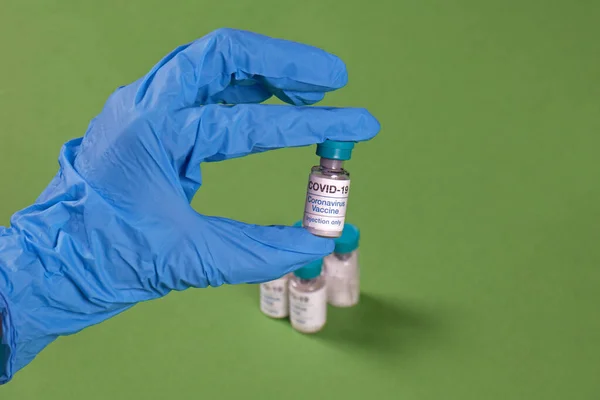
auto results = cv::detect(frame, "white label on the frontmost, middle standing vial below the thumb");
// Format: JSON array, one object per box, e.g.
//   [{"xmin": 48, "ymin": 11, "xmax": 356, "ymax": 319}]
[{"xmin": 290, "ymin": 286, "xmax": 327, "ymax": 333}]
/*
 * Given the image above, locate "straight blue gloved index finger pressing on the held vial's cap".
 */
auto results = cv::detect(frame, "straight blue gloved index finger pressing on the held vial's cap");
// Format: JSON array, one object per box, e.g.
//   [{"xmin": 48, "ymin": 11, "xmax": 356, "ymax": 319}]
[{"xmin": 173, "ymin": 104, "xmax": 380, "ymax": 167}]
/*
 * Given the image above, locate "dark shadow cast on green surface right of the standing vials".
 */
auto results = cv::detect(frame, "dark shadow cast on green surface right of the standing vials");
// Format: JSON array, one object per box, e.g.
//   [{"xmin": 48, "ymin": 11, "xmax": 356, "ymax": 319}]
[{"xmin": 315, "ymin": 293, "xmax": 439, "ymax": 361}]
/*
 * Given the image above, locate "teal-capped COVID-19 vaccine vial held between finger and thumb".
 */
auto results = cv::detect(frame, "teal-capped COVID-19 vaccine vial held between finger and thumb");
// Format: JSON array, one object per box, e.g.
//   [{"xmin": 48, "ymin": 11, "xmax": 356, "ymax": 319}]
[{"xmin": 302, "ymin": 140, "xmax": 354, "ymax": 238}]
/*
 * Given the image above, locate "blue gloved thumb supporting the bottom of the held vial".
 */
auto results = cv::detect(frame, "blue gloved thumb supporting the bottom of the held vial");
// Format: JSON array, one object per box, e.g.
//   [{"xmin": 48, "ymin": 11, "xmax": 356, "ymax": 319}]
[{"xmin": 161, "ymin": 215, "xmax": 334, "ymax": 290}]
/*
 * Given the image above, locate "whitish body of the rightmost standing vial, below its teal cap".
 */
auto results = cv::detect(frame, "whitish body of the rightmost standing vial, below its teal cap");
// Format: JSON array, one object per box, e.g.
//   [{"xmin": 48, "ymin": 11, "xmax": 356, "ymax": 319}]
[{"xmin": 323, "ymin": 254, "xmax": 360, "ymax": 307}]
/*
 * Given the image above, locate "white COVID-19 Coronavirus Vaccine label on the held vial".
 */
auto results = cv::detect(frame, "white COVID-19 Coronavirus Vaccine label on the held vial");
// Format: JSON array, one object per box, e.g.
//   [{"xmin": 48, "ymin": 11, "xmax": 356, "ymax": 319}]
[{"xmin": 303, "ymin": 175, "xmax": 350, "ymax": 234}]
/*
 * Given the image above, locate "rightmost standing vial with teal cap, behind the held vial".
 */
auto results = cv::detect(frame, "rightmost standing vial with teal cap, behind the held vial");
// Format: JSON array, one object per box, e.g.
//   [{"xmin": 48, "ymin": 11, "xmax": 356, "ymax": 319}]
[{"xmin": 323, "ymin": 224, "xmax": 360, "ymax": 307}]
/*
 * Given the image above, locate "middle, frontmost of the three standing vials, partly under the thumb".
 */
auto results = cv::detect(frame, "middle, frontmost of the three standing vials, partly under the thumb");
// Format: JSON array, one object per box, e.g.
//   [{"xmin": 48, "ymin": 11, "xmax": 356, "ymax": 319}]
[{"xmin": 289, "ymin": 259, "xmax": 327, "ymax": 333}]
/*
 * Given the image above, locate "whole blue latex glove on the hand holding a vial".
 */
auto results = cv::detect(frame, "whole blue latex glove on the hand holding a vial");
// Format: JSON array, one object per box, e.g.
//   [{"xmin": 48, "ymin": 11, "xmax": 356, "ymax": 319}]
[{"xmin": 0, "ymin": 29, "xmax": 379, "ymax": 383}]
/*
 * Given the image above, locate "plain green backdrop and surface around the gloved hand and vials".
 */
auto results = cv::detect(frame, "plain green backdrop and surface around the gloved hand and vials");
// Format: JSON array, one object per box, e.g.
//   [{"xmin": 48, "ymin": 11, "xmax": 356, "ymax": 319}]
[{"xmin": 0, "ymin": 0, "xmax": 600, "ymax": 400}]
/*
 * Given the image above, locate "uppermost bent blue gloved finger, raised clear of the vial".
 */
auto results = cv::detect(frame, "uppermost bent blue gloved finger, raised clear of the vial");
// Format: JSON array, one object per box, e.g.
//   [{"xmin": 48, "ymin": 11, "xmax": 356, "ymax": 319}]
[{"xmin": 135, "ymin": 29, "xmax": 348, "ymax": 109}]
